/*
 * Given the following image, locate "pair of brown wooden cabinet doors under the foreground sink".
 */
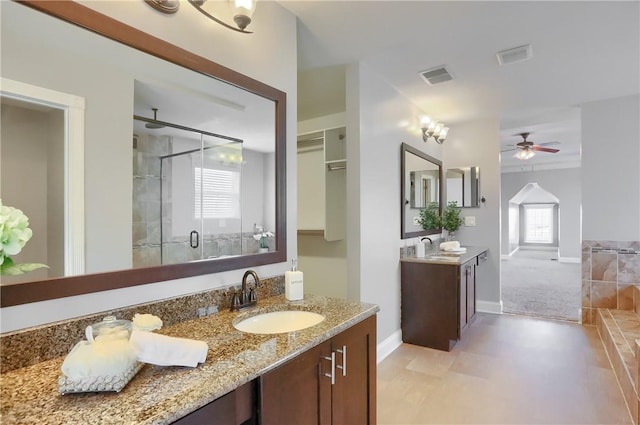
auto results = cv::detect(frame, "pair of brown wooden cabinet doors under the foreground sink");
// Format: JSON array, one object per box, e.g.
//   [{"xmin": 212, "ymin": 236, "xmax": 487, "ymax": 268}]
[{"xmin": 259, "ymin": 316, "xmax": 376, "ymax": 425}]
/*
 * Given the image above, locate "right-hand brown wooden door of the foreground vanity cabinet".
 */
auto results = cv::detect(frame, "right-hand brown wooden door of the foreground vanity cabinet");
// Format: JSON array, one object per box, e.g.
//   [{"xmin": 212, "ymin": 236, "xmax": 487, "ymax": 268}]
[{"xmin": 331, "ymin": 316, "xmax": 376, "ymax": 425}]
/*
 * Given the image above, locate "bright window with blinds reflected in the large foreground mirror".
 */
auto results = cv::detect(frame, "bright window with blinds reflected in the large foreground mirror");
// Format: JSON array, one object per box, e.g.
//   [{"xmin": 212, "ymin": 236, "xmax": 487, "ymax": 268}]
[{"xmin": 193, "ymin": 167, "xmax": 240, "ymax": 219}]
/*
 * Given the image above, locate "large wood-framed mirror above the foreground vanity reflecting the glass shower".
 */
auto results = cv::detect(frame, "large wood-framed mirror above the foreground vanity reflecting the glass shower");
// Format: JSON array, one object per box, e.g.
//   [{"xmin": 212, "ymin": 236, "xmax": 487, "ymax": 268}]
[{"xmin": 0, "ymin": 1, "xmax": 287, "ymax": 307}]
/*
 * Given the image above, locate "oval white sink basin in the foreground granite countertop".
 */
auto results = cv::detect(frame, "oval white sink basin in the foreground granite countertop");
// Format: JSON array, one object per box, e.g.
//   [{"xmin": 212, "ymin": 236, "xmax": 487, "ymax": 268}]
[{"xmin": 233, "ymin": 310, "xmax": 324, "ymax": 334}]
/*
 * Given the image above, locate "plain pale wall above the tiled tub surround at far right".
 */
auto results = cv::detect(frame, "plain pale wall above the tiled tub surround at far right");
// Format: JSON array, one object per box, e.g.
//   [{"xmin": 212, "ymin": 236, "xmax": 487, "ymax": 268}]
[{"xmin": 582, "ymin": 94, "xmax": 640, "ymax": 241}]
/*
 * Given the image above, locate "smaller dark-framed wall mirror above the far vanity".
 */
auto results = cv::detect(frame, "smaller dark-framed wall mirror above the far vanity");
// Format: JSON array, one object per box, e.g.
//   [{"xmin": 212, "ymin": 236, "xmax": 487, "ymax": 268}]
[{"xmin": 400, "ymin": 143, "xmax": 442, "ymax": 239}]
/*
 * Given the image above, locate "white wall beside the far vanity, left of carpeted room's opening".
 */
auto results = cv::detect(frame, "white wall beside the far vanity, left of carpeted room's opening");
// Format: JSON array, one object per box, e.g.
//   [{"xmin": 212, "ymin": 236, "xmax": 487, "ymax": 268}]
[{"xmin": 443, "ymin": 117, "xmax": 501, "ymax": 312}]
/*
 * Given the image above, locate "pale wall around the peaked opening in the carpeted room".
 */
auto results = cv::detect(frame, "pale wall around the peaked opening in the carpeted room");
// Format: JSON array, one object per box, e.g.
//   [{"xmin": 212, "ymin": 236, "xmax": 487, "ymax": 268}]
[{"xmin": 502, "ymin": 168, "xmax": 582, "ymax": 260}]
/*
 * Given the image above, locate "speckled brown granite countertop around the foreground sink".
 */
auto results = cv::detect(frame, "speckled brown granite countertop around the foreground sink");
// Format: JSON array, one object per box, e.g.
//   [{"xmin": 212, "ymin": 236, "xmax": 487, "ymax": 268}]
[{"xmin": 0, "ymin": 294, "xmax": 379, "ymax": 425}]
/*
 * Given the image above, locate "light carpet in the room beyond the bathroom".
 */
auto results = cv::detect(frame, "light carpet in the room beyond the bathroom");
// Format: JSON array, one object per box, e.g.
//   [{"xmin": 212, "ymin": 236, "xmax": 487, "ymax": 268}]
[{"xmin": 500, "ymin": 250, "xmax": 582, "ymax": 321}]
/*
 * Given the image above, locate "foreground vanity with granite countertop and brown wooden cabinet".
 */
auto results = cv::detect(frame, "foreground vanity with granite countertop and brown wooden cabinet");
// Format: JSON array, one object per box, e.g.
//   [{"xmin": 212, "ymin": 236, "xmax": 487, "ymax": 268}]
[{"xmin": 0, "ymin": 295, "xmax": 378, "ymax": 425}]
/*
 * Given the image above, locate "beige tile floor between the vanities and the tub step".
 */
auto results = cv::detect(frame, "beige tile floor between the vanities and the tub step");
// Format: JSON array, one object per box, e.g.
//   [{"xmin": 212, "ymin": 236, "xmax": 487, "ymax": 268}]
[{"xmin": 378, "ymin": 313, "xmax": 632, "ymax": 425}]
